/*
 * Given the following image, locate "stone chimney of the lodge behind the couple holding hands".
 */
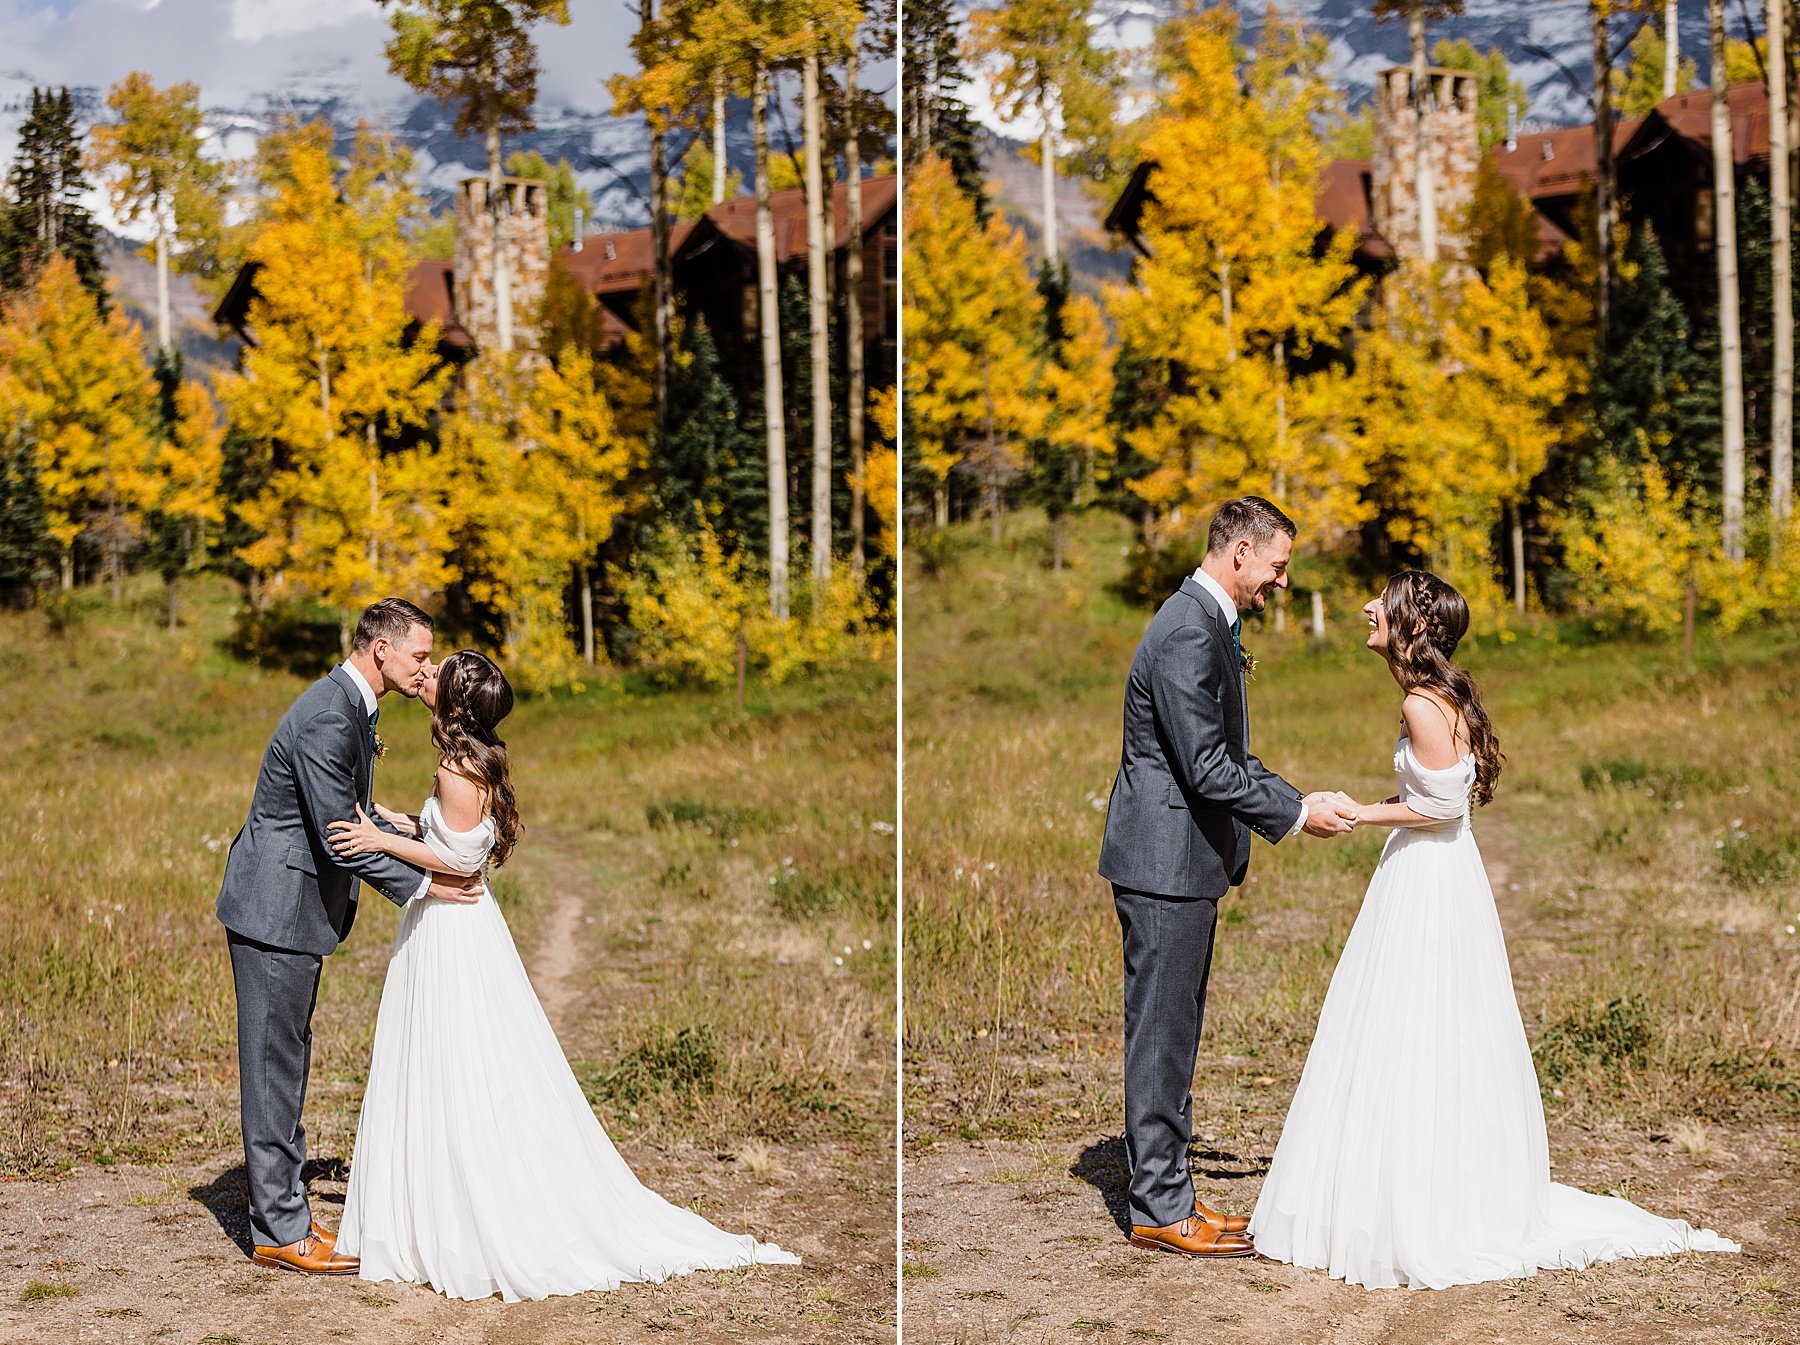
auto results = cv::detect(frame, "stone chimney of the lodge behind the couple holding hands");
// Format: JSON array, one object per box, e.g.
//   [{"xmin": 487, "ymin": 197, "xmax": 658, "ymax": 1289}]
[{"xmin": 1370, "ymin": 65, "xmax": 1480, "ymax": 263}]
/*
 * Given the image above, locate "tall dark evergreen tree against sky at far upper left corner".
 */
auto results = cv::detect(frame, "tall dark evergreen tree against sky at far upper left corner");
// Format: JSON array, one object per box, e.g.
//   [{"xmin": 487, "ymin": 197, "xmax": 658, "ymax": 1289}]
[{"xmin": 0, "ymin": 88, "xmax": 106, "ymax": 317}]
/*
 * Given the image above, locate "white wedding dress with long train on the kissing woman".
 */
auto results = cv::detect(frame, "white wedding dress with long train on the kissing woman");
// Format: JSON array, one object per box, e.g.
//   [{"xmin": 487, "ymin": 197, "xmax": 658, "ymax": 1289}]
[{"xmin": 338, "ymin": 796, "xmax": 799, "ymax": 1304}]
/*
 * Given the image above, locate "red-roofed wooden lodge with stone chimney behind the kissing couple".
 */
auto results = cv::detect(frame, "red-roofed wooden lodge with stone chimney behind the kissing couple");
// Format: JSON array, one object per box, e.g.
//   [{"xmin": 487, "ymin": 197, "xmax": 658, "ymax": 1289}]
[{"xmin": 212, "ymin": 175, "xmax": 900, "ymax": 405}]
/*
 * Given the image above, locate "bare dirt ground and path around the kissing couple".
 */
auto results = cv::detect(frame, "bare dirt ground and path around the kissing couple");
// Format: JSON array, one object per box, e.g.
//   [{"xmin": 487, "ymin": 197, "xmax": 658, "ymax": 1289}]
[{"xmin": 0, "ymin": 839, "xmax": 893, "ymax": 1345}]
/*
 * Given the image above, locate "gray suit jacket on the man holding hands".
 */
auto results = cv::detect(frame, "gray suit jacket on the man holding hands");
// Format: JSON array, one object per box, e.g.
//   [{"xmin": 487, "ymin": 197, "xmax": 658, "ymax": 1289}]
[{"xmin": 1100, "ymin": 578, "xmax": 1300, "ymax": 900}]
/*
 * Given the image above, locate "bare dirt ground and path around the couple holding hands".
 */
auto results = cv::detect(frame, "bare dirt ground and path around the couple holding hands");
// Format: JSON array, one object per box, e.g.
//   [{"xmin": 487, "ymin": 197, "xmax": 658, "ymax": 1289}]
[{"xmin": 902, "ymin": 834, "xmax": 1800, "ymax": 1345}]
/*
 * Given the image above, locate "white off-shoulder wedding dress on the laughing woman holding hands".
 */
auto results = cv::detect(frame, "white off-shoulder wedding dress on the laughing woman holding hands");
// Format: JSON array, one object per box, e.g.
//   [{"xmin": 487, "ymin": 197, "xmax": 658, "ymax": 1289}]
[{"xmin": 1251, "ymin": 735, "xmax": 1739, "ymax": 1289}]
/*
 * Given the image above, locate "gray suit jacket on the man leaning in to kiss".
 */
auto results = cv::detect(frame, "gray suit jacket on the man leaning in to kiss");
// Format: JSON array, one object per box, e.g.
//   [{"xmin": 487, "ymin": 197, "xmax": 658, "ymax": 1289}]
[{"xmin": 216, "ymin": 668, "xmax": 425, "ymax": 956}]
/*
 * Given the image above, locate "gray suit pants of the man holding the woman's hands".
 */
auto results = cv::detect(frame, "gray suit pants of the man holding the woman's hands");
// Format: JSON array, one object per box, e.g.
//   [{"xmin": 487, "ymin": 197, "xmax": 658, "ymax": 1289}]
[{"xmin": 1112, "ymin": 884, "xmax": 1219, "ymax": 1228}]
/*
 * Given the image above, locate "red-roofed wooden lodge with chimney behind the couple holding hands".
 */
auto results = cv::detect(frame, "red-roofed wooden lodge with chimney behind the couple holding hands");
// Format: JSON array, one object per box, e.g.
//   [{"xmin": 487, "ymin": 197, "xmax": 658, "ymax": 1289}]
[{"xmin": 1105, "ymin": 67, "xmax": 1769, "ymax": 304}]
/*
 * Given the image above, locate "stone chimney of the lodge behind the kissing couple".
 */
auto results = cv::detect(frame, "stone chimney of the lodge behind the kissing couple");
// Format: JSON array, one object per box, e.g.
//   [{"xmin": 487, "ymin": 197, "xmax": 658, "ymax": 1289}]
[{"xmin": 454, "ymin": 178, "xmax": 551, "ymax": 351}]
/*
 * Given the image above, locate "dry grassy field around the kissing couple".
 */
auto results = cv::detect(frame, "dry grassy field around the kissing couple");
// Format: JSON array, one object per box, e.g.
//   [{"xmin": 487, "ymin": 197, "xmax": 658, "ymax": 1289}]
[{"xmin": 0, "ymin": 568, "xmax": 895, "ymax": 1209}]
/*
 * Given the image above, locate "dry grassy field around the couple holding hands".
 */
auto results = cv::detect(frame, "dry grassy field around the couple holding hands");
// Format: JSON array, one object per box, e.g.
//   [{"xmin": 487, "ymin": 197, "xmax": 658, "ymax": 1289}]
[{"xmin": 902, "ymin": 515, "xmax": 1800, "ymax": 1340}]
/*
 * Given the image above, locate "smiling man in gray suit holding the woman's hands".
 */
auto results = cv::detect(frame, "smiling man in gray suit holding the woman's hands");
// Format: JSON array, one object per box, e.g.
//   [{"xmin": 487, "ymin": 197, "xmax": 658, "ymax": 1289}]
[{"xmin": 1100, "ymin": 495, "xmax": 1352, "ymax": 1257}]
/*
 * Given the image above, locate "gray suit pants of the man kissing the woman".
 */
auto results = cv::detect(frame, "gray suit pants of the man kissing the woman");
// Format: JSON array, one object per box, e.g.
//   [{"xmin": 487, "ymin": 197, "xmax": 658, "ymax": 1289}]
[{"xmin": 225, "ymin": 929, "xmax": 324, "ymax": 1248}]
